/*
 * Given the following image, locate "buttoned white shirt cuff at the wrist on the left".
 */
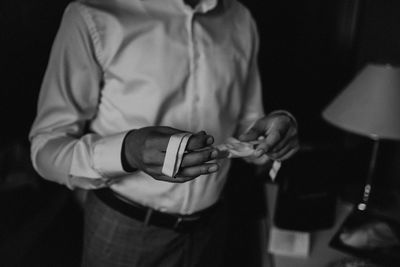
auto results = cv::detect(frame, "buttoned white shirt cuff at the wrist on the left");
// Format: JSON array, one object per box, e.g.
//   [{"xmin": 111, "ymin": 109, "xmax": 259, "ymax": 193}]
[{"xmin": 93, "ymin": 132, "xmax": 127, "ymax": 178}]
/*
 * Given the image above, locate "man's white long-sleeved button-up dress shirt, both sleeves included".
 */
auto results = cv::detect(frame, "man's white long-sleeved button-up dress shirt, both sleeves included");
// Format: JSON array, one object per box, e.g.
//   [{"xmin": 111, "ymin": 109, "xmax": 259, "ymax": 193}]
[{"xmin": 30, "ymin": 0, "xmax": 263, "ymax": 214}]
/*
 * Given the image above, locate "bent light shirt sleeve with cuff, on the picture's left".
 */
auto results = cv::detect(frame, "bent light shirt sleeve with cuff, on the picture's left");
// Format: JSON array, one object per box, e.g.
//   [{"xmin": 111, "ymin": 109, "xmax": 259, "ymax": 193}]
[{"xmin": 29, "ymin": 4, "xmax": 126, "ymax": 189}]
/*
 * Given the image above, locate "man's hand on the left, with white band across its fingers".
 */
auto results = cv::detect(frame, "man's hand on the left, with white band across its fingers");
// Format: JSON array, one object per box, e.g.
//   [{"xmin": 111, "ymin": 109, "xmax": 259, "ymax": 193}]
[{"xmin": 123, "ymin": 126, "xmax": 223, "ymax": 183}]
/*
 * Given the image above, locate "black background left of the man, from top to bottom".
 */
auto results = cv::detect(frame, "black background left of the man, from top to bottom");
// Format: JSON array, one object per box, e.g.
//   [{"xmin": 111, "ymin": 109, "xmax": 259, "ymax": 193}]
[{"xmin": 0, "ymin": 0, "xmax": 82, "ymax": 267}]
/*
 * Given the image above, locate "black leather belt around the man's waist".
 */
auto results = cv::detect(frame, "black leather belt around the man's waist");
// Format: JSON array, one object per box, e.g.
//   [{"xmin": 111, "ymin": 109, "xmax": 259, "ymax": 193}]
[{"xmin": 94, "ymin": 187, "xmax": 219, "ymax": 231}]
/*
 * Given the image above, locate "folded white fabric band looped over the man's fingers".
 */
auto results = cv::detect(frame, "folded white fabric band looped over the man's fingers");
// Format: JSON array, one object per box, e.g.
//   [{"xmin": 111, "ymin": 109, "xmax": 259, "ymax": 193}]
[{"xmin": 161, "ymin": 133, "xmax": 192, "ymax": 177}]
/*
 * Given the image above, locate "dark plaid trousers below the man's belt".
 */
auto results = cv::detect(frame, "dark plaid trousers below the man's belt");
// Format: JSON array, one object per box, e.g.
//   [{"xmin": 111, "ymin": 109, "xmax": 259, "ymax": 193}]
[{"xmin": 82, "ymin": 192, "xmax": 227, "ymax": 267}]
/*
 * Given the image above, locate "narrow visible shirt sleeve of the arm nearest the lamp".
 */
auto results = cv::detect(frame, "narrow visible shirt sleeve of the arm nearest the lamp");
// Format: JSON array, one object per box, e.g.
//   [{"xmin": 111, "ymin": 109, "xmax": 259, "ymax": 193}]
[{"xmin": 236, "ymin": 14, "xmax": 264, "ymax": 136}]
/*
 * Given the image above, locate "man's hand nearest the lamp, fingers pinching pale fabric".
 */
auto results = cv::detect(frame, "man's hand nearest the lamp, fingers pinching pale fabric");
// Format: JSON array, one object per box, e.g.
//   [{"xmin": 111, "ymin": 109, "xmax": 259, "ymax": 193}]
[{"xmin": 239, "ymin": 113, "xmax": 299, "ymax": 163}]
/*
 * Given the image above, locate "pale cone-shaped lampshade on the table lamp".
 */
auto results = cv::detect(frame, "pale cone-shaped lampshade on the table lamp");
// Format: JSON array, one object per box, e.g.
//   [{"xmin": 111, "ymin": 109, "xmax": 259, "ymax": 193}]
[{"xmin": 322, "ymin": 64, "xmax": 400, "ymax": 140}]
